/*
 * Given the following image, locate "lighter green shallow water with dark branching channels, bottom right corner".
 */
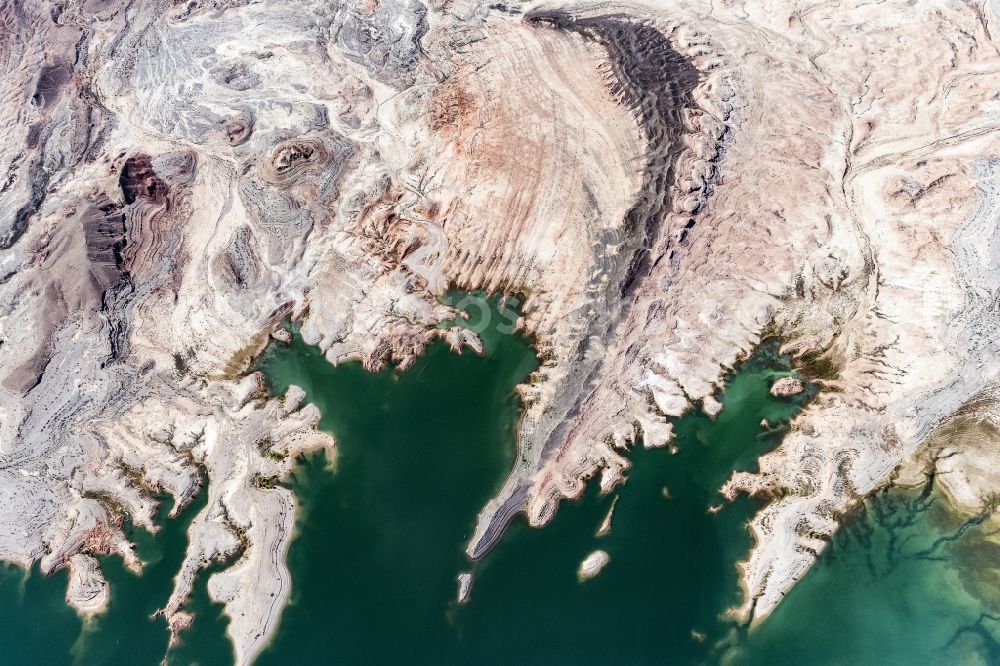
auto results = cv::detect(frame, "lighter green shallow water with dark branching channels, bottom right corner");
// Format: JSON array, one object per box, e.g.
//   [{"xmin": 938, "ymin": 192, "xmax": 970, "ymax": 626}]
[{"xmin": 732, "ymin": 485, "xmax": 1000, "ymax": 666}]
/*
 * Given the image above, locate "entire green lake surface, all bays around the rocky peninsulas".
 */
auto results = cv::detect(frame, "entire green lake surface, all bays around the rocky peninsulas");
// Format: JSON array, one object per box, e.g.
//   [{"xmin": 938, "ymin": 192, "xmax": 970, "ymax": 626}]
[{"xmin": 0, "ymin": 294, "xmax": 1000, "ymax": 665}]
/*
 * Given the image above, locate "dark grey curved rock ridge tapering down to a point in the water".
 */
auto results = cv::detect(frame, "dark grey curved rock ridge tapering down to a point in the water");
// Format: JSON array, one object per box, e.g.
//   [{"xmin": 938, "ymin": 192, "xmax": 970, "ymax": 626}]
[{"xmin": 469, "ymin": 12, "xmax": 699, "ymax": 558}]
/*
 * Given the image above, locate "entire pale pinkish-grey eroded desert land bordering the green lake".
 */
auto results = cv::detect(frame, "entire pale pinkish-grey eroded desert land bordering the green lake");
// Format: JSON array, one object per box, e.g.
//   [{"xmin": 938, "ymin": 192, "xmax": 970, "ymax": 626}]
[{"xmin": 0, "ymin": 0, "xmax": 1000, "ymax": 663}]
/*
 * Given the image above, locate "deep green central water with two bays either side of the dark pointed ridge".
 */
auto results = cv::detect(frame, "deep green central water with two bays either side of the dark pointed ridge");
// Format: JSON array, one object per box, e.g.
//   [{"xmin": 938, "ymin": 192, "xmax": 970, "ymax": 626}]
[{"xmin": 250, "ymin": 296, "xmax": 806, "ymax": 664}]
